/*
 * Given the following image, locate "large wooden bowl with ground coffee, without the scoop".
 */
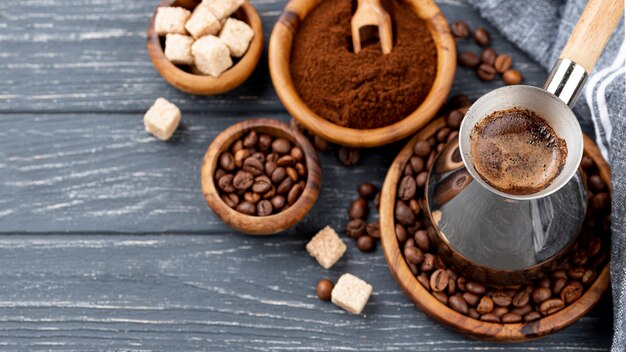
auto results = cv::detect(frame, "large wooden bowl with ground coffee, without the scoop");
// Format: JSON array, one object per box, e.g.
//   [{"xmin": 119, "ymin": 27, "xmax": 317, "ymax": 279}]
[{"xmin": 269, "ymin": 0, "xmax": 456, "ymax": 147}]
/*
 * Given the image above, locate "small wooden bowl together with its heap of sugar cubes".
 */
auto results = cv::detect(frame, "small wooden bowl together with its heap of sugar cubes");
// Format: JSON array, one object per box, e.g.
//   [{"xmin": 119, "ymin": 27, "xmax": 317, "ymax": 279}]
[{"xmin": 147, "ymin": 0, "xmax": 264, "ymax": 95}]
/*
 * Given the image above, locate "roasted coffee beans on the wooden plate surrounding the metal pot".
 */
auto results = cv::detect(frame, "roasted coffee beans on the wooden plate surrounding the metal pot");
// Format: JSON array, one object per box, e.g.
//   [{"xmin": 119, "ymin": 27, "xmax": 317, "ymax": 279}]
[{"xmin": 395, "ymin": 98, "xmax": 610, "ymax": 324}]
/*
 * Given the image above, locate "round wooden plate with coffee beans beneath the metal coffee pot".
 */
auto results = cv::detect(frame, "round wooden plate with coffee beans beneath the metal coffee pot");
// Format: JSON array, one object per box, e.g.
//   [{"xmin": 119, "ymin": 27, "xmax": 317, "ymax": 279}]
[{"xmin": 380, "ymin": 112, "xmax": 611, "ymax": 342}]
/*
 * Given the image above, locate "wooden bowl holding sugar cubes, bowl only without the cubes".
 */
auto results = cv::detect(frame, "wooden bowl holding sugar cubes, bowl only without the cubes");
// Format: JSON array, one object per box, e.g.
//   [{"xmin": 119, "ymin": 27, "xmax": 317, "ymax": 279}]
[{"xmin": 147, "ymin": 0, "xmax": 263, "ymax": 95}]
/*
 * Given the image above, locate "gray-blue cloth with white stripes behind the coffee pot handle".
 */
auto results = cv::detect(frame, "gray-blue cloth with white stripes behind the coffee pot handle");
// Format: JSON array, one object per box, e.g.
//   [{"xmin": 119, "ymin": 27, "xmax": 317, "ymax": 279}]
[{"xmin": 468, "ymin": 0, "xmax": 626, "ymax": 351}]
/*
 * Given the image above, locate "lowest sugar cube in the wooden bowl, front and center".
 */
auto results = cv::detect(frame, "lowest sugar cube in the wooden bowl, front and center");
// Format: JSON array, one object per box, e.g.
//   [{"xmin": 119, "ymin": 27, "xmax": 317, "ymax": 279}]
[{"xmin": 191, "ymin": 35, "xmax": 233, "ymax": 77}]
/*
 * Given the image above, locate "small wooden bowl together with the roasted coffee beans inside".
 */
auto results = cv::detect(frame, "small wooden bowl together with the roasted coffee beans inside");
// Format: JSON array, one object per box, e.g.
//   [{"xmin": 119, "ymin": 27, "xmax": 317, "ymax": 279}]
[{"xmin": 201, "ymin": 119, "xmax": 321, "ymax": 235}]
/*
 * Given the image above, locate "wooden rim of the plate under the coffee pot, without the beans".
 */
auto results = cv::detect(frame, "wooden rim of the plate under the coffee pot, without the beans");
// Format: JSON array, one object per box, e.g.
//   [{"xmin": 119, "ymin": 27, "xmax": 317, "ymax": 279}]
[{"xmin": 380, "ymin": 118, "xmax": 611, "ymax": 342}]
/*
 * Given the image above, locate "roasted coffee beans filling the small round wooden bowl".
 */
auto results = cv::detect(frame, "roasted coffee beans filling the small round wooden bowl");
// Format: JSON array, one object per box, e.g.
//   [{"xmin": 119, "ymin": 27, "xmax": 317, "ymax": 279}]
[{"xmin": 214, "ymin": 131, "xmax": 307, "ymax": 216}]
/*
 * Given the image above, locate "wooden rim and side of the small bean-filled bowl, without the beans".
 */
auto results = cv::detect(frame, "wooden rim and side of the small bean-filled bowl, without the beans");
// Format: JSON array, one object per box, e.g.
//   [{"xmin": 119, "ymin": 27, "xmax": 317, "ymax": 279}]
[{"xmin": 200, "ymin": 119, "xmax": 321, "ymax": 235}]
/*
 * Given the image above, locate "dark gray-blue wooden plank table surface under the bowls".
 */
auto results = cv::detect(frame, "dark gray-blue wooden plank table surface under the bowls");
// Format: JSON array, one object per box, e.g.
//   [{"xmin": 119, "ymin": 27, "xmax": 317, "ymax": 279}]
[{"xmin": 0, "ymin": 0, "xmax": 612, "ymax": 351}]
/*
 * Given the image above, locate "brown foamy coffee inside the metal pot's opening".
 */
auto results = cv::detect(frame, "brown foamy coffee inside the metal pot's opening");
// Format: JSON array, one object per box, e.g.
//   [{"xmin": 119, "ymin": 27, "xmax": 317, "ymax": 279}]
[{"xmin": 470, "ymin": 108, "xmax": 567, "ymax": 195}]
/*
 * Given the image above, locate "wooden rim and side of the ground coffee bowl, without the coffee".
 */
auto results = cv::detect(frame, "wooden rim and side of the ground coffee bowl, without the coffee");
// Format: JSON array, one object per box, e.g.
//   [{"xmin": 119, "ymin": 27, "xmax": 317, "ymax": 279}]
[{"xmin": 269, "ymin": 0, "xmax": 456, "ymax": 147}]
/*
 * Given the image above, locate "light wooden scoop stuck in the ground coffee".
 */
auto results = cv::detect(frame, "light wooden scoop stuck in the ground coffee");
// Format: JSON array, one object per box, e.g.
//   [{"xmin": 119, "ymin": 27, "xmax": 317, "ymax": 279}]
[{"xmin": 351, "ymin": 0, "xmax": 393, "ymax": 54}]
